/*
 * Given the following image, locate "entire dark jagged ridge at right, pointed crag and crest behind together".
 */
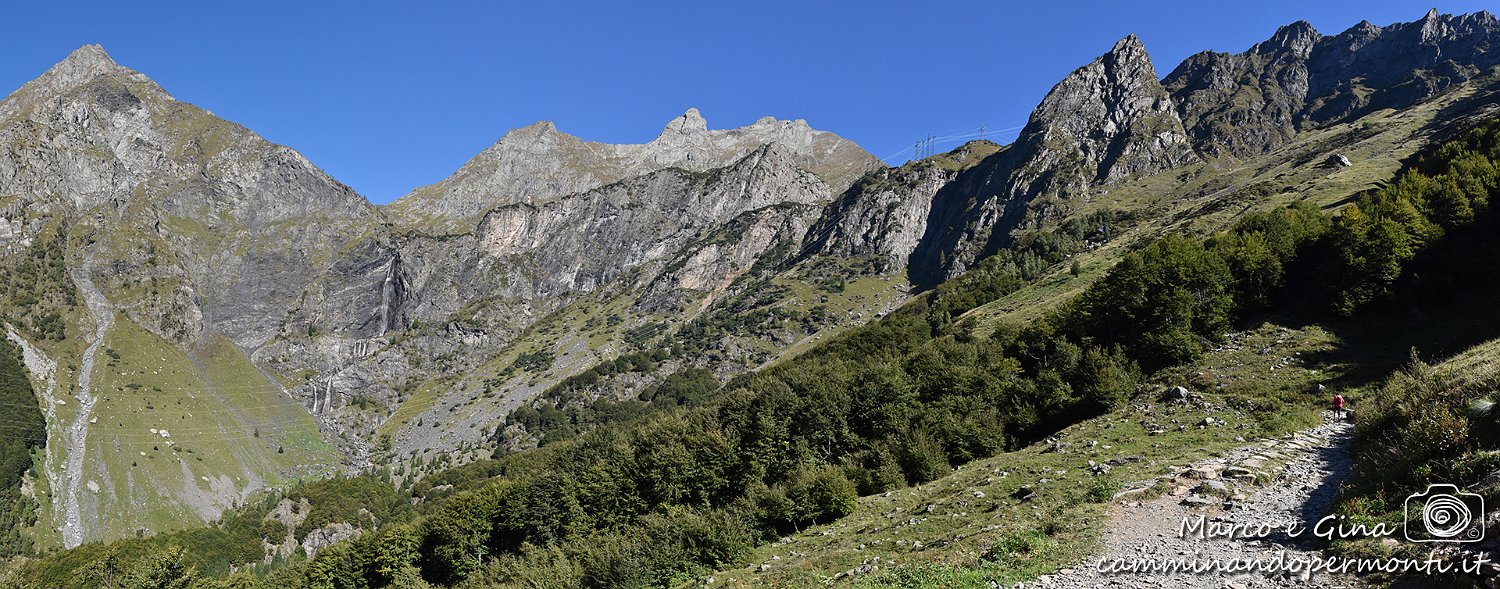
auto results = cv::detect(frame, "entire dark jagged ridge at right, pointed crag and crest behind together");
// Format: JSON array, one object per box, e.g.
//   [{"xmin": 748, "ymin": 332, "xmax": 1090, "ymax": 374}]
[{"xmin": 912, "ymin": 10, "xmax": 1500, "ymax": 285}]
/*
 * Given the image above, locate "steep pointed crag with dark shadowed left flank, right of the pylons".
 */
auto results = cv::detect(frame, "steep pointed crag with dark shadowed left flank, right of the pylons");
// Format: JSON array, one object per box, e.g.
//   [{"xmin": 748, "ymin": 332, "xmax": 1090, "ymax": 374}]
[{"xmin": 909, "ymin": 36, "xmax": 1197, "ymax": 285}]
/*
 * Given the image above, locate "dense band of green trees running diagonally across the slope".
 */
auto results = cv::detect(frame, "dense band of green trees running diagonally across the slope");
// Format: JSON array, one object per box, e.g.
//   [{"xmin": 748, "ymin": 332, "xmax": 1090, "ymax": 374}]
[{"xmin": 2, "ymin": 116, "xmax": 1500, "ymax": 588}]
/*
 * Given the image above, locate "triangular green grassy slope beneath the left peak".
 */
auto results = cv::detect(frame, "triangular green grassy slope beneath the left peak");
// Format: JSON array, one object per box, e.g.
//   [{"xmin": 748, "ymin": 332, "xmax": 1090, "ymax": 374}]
[{"xmin": 38, "ymin": 316, "xmax": 341, "ymax": 546}]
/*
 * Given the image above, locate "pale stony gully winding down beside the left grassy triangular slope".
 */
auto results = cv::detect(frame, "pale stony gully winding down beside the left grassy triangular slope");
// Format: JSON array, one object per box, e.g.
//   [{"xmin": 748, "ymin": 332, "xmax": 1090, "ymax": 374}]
[{"xmin": 63, "ymin": 261, "xmax": 114, "ymax": 549}]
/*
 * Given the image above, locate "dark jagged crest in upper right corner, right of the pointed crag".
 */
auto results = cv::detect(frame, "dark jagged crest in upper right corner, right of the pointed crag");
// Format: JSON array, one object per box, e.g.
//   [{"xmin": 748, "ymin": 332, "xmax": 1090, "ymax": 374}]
[{"xmin": 1164, "ymin": 10, "xmax": 1500, "ymax": 157}]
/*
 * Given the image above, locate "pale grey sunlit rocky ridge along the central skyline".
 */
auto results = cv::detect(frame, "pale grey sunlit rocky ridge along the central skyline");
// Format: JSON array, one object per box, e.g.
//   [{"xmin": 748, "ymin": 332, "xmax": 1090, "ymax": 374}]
[{"xmin": 390, "ymin": 108, "xmax": 879, "ymax": 223}]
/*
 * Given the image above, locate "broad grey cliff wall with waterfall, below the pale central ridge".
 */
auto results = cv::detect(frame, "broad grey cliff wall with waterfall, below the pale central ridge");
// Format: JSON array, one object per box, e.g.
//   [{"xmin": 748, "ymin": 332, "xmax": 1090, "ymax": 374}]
[{"xmin": 255, "ymin": 144, "xmax": 833, "ymax": 460}]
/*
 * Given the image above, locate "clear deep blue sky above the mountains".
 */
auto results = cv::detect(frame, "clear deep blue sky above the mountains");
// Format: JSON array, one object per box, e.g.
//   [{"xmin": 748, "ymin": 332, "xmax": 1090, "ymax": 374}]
[{"xmin": 0, "ymin": 0, "xmax": 1494, "ymax": 202}]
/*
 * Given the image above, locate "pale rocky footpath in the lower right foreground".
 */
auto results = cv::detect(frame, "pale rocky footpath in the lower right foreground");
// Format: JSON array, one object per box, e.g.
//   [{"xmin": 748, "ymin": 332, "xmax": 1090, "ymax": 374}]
[{"xmin": 1028, "ymin": 421, "xmax": 1359, "ymax": 589}]
